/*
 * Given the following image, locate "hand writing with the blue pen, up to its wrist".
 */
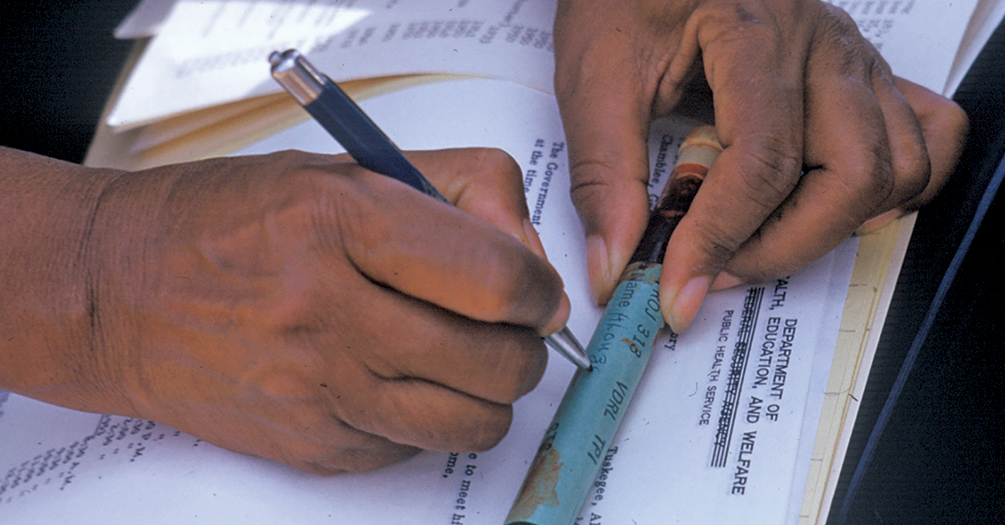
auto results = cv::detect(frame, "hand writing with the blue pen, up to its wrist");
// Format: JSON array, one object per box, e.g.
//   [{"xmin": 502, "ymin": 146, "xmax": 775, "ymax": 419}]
[{"xmin": 0, "ymin": 144, "xmax": 569, "ymax": 474}]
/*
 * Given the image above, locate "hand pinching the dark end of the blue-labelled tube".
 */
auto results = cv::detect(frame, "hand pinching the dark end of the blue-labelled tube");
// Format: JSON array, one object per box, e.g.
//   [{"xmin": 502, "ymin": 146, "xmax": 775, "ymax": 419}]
[{"xmin": 555, "ymin": 0, "xmax": 967, "ymax": 332}]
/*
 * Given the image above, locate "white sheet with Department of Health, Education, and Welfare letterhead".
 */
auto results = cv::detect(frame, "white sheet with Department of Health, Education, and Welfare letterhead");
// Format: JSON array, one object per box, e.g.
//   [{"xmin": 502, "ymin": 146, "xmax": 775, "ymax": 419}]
[{"xmin": 0, "ymin": 79, "xmax": 855, "ymax": 525}]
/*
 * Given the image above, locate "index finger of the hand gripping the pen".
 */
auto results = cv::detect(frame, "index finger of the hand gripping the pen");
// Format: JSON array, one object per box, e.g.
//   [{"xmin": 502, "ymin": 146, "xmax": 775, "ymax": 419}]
[{"xmin": 329, "ymin": 152, "xmax": 568, "ymax": 332}]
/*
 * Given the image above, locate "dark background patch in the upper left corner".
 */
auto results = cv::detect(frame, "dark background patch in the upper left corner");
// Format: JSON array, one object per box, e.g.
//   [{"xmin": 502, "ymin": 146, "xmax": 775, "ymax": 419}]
[{"xmin": 0, "ymin": 0, "xmax": 136, "ymax": 162}]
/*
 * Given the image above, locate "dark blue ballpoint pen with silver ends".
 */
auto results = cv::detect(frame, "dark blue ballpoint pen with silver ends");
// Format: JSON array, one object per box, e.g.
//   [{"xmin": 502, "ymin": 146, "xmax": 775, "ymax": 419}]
[{"xmin": 268, "ymin": 49, "xmax": 590, "ymax": 369}]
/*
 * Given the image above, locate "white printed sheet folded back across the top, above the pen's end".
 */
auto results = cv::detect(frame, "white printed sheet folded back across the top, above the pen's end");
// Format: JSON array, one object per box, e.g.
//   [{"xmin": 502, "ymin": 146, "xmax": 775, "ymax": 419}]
[{"xmin": 108, "ymin": 0, "xmax": 976, "ymax": 129}]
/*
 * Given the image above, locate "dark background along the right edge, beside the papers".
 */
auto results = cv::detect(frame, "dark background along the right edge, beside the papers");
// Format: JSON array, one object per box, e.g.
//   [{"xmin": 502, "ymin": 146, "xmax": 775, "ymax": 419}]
[{"xmin": 829, "ymin": 18, "xmax": 1005, "ymax": 525}]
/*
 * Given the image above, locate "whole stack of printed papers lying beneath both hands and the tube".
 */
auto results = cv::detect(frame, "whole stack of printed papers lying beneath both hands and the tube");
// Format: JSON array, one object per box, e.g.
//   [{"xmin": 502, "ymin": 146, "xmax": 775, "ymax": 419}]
[{"xmin": 0, "ymin": 0, "xmax": 1005, "ymax": 525}]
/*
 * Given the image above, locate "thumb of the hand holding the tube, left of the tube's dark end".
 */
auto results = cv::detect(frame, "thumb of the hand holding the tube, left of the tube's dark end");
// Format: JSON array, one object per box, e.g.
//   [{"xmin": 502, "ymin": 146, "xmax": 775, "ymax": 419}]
[{"xmin": 555, "ymin": 48, "xmax": 651, "ymax": 304}]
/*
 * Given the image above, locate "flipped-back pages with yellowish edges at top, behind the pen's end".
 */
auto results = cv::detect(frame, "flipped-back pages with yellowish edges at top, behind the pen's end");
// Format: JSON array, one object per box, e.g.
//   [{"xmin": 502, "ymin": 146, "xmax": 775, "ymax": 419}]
[{"xmin": 89, "ymin": 0, "xmax": 1003, "ymax": 168}]
